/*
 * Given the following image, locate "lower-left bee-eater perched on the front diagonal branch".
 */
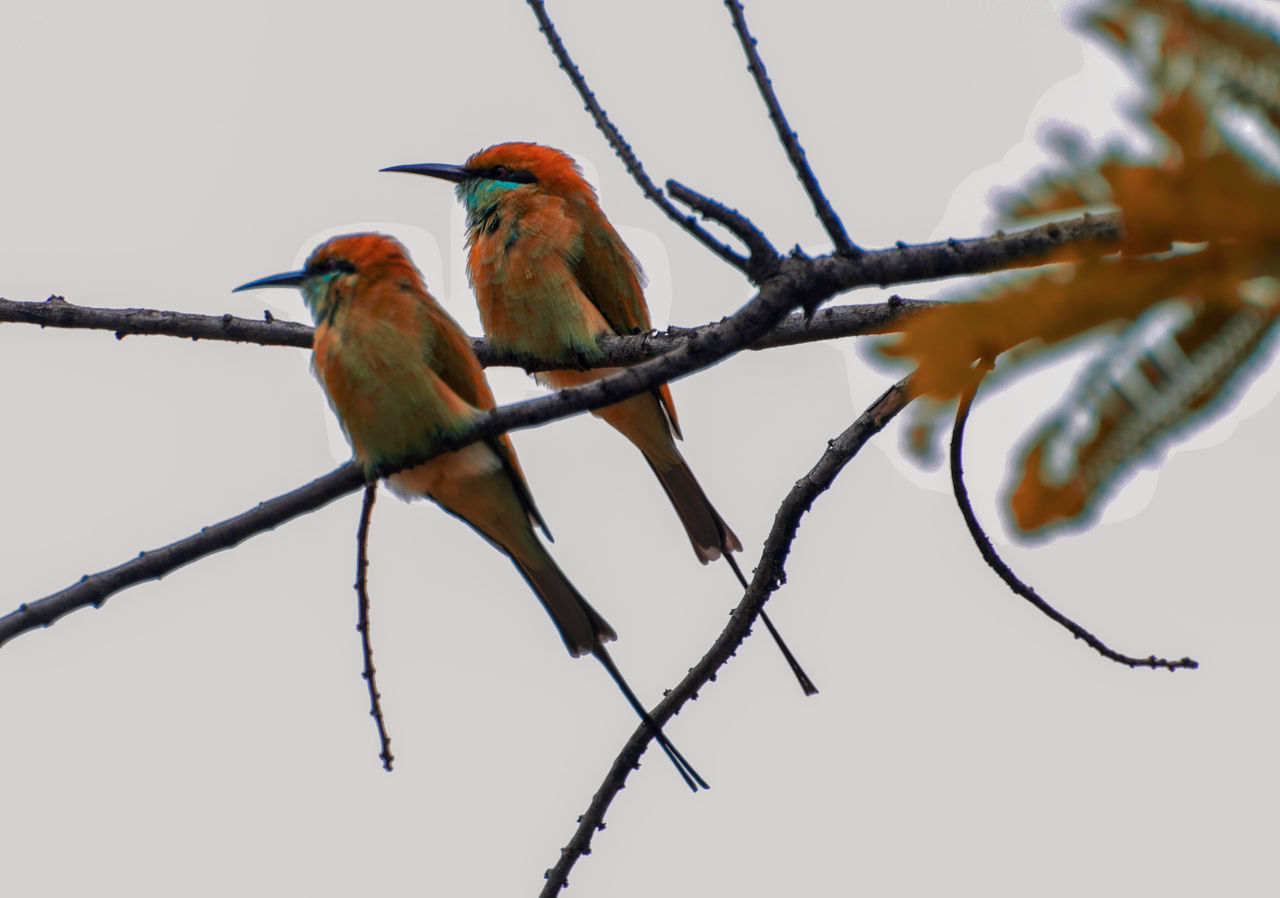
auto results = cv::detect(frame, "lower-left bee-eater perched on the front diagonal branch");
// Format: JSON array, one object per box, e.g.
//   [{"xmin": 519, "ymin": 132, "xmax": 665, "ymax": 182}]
[{"xmin": 236, "ymin": 234, "xmax": 708, "ymax": 792}]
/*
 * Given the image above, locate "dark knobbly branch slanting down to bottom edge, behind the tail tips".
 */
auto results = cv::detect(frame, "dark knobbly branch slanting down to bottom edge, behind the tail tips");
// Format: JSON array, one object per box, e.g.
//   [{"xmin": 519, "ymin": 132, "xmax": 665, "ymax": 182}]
[{"xmin": 540, "ymin": 379, "xmax": 910, "ymax": 898}]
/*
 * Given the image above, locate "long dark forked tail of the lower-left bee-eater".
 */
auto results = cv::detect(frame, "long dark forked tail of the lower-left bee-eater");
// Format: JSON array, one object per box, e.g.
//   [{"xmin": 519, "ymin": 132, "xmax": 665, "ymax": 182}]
[{"xmin": 511, "ymin": 551, "xmax": 710, "ymax": 792}]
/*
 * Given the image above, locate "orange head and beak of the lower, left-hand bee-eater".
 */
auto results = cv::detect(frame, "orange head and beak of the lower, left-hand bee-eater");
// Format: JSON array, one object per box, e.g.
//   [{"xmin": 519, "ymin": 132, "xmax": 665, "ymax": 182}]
[{"xmin": 233, "ymin": 234, "xmax": 426, "ymax": 324}]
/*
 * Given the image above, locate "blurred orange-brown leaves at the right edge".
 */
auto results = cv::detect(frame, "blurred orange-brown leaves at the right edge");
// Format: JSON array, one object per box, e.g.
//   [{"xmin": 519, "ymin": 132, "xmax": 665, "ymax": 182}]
[{"xmin": 882, "ymin": 0, "xmax": 1280, "ymax": 533}]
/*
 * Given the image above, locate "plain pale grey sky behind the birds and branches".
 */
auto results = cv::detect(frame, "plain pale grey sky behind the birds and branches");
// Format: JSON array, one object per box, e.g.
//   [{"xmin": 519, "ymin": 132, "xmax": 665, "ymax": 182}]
[{"xmin": 0, "ymin": 0, "xmax": 1280, "ymax": 897}]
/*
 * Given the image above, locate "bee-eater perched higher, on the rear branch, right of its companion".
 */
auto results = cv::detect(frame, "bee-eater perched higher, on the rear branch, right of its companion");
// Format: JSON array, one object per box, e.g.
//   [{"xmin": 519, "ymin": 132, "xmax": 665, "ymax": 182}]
[{"xmin": 383, "ymin": 143, "xmax": 818, "ymax": 695}]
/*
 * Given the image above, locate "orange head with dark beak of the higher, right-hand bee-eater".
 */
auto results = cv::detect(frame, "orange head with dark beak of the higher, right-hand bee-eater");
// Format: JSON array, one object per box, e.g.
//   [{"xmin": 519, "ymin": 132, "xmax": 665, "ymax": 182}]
[{"xmin": 383, "ymin": 143, "xmax": 595, "ymax": 226}]
